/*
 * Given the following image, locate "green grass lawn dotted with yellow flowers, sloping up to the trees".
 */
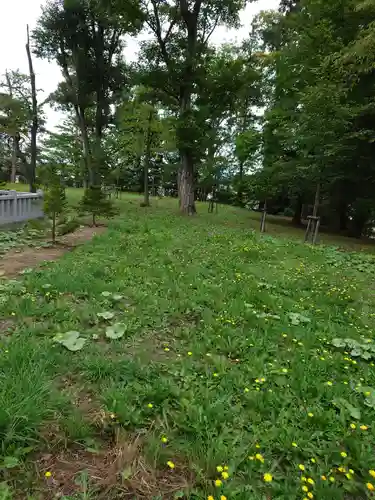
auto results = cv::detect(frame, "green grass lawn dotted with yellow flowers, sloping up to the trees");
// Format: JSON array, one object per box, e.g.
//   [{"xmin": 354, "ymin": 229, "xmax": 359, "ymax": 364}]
[{"xmin": 0, "ymin": 196, "xmax": 375, "ymax": 500}]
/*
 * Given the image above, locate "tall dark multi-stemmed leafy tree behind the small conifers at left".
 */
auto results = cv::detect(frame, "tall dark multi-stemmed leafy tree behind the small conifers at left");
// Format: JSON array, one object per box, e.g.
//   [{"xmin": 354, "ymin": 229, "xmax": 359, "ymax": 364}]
[{"xmin": 34, "ymin": 0, "xmax": 142, "ymax": 185}]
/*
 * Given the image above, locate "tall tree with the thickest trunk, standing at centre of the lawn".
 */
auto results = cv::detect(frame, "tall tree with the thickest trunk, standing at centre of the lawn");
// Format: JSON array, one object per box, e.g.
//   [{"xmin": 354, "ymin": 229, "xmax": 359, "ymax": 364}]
[{"xmin": 142, "ymin": 0, "xmax": 254, "ymax": 214}]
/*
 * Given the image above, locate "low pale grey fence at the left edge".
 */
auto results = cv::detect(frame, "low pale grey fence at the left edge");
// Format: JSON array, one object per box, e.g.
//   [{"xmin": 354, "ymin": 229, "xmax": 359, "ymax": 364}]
[{"xmin": 0, "ymin": 190, "xmax": 44, "ymax": 226}]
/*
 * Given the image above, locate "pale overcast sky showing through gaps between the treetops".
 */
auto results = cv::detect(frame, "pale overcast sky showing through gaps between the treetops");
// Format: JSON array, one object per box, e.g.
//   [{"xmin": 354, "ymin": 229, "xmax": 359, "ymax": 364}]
[{"xmin": 0, "ymin": 0, "xmax": 279, "ymax": 129}]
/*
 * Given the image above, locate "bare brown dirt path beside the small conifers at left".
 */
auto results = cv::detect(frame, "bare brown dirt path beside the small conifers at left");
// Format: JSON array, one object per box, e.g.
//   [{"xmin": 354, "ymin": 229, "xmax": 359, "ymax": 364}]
[{"xmin": 0, "ymin": 227, "xmax": 107, "ymax": 278}]
